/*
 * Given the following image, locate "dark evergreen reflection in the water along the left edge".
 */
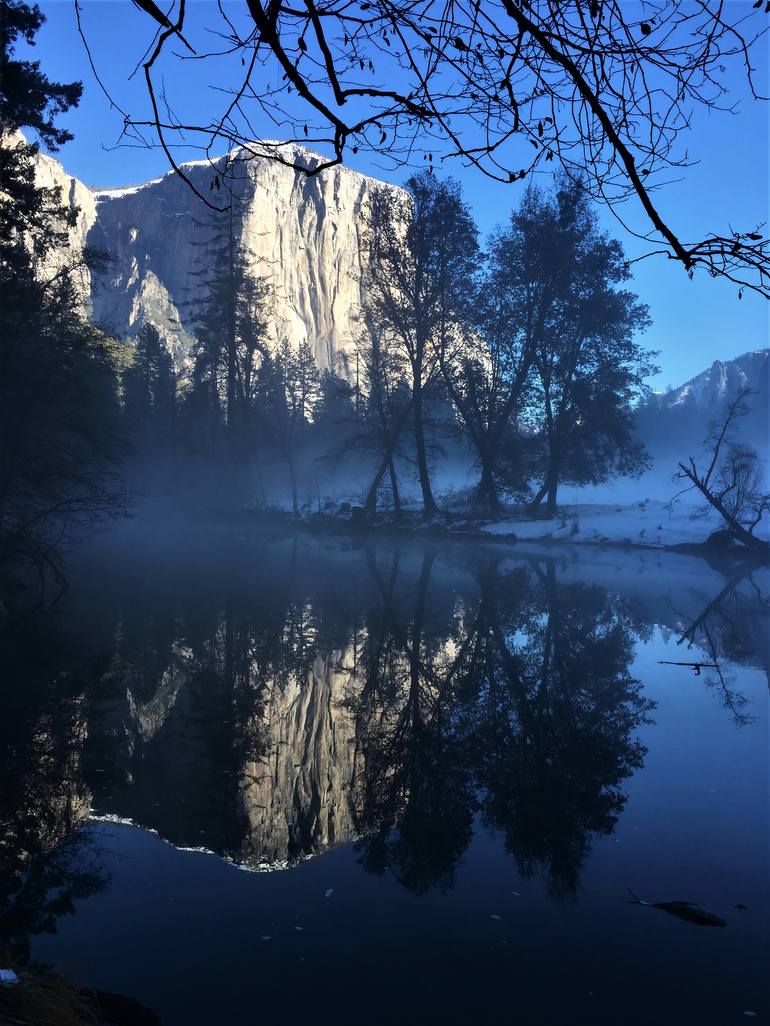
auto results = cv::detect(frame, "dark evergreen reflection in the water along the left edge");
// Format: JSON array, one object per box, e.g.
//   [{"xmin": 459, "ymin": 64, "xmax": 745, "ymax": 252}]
[{"xmin": 0, "ymin": 616, "xmax": 109, "ymax": 962}]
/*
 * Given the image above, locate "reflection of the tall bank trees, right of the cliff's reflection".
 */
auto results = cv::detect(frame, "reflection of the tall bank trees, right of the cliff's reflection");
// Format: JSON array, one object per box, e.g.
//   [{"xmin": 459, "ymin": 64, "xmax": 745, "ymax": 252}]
[{"xmin": 359, "ymin": 554, "xmax": 652, "ymax": 897}]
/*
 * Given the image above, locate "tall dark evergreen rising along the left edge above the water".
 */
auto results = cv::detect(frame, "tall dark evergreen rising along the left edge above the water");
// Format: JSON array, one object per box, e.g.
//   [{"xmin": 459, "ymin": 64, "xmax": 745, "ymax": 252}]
[{"xmin": 0, "ymin": 0, "xmax": 124, "ymax": 578}]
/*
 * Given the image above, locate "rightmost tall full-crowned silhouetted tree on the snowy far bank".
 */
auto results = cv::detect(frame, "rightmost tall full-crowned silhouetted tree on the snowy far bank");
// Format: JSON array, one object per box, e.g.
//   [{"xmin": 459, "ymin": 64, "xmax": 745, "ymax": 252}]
[{"xmin": 514, "ymin": 181, "xmax": 652, "ymax": 516}]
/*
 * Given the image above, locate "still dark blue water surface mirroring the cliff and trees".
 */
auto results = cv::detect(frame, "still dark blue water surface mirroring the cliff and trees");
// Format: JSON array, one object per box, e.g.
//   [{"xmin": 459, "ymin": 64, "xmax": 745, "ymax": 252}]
[{"xmin": 0, "ymin": 528, "xmax": 770, "ymax": 1026}]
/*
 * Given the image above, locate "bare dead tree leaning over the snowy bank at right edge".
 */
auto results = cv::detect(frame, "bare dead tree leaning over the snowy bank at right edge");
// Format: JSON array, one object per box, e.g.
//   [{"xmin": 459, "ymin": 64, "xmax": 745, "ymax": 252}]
[{"xmin": 676, "ymin": 389, "xmax": 770, "ymax": 558}]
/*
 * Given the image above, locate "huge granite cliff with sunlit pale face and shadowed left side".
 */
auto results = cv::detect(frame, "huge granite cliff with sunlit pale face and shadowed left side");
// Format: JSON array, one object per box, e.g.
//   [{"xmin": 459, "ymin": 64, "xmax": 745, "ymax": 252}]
[{"xmin": 33, "ymin": 140, "xmax": 398, "ymax": 373}]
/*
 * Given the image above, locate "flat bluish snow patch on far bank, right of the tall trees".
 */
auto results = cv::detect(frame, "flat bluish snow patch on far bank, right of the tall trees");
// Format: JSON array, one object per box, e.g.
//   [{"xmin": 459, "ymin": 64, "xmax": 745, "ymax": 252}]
[{"xmin": 478, "ymin": 502, "xmax": 765, "ymax": 548}]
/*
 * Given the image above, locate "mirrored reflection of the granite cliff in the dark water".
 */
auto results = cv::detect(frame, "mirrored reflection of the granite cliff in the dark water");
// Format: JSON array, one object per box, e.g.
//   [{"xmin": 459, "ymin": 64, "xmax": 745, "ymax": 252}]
[{"xmin": 91, "ymin": 643, "xmax": 361, "ymax": 870}]
